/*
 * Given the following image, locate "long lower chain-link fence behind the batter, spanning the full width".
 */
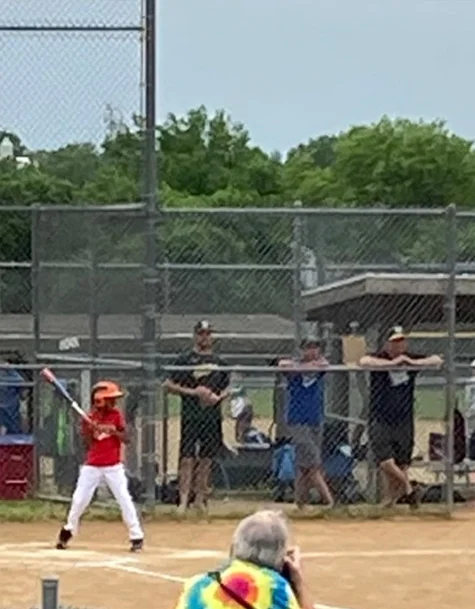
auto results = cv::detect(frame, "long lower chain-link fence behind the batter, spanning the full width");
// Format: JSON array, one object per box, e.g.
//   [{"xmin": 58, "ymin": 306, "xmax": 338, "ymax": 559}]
[{"xmin": 0, "ymin": 204, "xmax": 475, "ymax": 507}]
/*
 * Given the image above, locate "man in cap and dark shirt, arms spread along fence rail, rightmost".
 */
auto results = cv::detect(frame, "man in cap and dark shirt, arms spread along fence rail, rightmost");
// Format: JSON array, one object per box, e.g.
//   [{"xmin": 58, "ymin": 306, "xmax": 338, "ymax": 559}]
[{"xmin": 360, "ymin": 326, "xmax": 442, "ymax": 507}]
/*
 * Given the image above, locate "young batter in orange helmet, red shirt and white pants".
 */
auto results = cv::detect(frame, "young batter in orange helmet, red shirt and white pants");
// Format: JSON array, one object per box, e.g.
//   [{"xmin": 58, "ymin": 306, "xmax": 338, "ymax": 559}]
[{"xmin": 56, "ymin": 381, "xmax": 143, "ymax": 552}]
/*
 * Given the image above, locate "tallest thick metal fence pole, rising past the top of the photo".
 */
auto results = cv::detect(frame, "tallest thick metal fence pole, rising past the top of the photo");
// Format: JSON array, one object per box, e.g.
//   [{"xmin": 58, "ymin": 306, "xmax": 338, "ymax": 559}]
[{"xmin": 142, "ymin": 0, "xmax": 160, "ymax": 505}]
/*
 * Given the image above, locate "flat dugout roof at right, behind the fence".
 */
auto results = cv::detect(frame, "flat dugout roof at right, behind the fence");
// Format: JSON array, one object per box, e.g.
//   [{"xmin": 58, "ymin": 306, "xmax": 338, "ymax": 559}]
[{"xmin": 303, "ymin": 273, "xmax": 475, "ymax": 332}]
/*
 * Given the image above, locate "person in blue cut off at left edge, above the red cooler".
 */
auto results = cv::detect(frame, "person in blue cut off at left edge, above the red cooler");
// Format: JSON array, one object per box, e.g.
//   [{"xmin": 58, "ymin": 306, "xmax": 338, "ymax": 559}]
[{"xmin": 0, "ymin": 363, "xmax": 25, "ymax": 435}]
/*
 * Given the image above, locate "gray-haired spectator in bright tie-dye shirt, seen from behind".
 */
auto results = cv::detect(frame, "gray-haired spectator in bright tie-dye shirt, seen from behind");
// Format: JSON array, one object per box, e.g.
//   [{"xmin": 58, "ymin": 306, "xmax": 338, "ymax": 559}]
[{"xmin": 176, "ymin": 510, "xmax": 313, "ymax": 609}]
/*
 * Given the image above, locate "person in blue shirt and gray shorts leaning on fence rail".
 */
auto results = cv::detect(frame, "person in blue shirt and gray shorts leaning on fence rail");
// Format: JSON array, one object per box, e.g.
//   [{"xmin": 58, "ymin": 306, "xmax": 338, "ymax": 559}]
[{"xmin": 279, "ymin": 338, "xmax": 333, "ymax": 509}]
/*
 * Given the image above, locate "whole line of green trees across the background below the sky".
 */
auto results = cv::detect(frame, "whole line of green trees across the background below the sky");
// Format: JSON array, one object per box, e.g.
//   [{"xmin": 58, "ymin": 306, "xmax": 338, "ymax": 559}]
[{"xmin": 0, "ymin": 107, "xmax": 475, "ymax": 314}]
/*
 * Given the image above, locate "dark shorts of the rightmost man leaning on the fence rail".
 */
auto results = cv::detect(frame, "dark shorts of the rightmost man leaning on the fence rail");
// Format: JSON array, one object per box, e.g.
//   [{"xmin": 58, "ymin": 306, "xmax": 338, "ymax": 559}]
[{"xmin": 369, "ymin": 419, "xmax": 414, "ymax": 466}]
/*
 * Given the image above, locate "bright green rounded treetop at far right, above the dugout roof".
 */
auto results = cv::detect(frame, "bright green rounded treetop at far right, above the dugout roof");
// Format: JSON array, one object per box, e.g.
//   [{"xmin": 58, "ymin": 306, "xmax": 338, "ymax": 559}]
[{"xmin": 334, "ymin": 117, "xmax": 475, "ymax": 207}]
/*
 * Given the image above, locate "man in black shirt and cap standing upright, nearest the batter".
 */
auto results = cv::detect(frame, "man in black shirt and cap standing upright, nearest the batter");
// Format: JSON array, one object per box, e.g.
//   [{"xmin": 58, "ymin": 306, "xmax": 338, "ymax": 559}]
[{"xmin": 165, "ymin": 321, "xmax": 229, "ymax": 513}]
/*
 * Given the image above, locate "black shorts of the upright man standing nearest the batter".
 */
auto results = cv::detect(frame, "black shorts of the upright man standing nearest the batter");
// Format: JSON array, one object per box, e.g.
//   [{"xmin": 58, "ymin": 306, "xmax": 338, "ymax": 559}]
[{"xmin": 180, "ymin": 413, "xmax": 223, "ymax": 459}]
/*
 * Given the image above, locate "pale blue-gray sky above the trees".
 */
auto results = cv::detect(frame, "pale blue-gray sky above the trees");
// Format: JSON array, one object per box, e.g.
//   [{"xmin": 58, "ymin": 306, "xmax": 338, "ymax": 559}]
[{"xmin": 0, "ymin": 0, "xmax": 475, "ymax": 153}]
